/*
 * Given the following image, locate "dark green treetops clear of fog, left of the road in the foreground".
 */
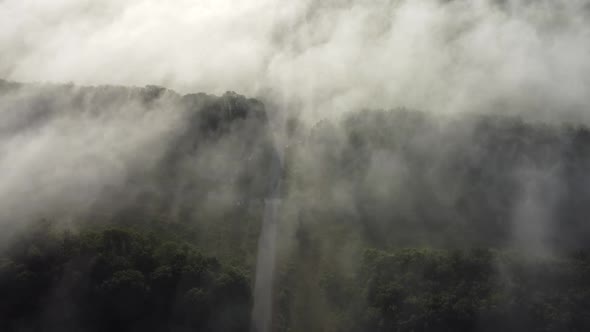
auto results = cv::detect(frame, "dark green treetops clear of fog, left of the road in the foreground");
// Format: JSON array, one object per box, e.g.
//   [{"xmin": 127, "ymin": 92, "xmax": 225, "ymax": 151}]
[{"xmin": 0, "ymin": 223, "xmax": 251, "ymax": 331}]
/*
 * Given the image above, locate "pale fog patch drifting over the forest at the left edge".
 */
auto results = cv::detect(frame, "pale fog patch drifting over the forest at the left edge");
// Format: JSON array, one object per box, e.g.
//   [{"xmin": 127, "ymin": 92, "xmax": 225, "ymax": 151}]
[{"xmin": 0, "ymin": 85, "xmax": 183, "ymax": 230}]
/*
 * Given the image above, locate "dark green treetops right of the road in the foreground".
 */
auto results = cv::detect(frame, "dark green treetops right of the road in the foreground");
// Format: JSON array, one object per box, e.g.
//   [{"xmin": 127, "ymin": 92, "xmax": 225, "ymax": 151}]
[{"xmin": 323, "ymin": 249, "xmax": 590, "ymax": 331}]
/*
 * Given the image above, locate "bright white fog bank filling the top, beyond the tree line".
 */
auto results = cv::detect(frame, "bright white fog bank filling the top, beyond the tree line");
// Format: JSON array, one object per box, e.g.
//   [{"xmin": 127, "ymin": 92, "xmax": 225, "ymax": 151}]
[{"xmin": 0, "ymin": 0, "xmax": 590, "ymax": 118}]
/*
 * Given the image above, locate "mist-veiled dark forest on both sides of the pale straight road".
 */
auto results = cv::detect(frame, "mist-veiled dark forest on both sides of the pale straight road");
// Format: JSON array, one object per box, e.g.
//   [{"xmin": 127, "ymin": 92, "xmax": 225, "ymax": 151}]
[{"xmin": 0, "ymin": 81, "xmax": 590, "ymax": 331}]
